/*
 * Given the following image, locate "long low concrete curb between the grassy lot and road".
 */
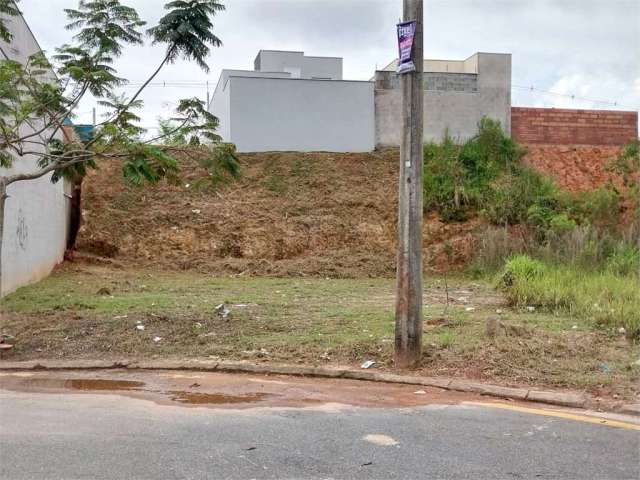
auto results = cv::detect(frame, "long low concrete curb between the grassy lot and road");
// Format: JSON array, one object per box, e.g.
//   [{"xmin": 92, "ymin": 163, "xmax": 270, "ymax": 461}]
[{"xmin": 0, "ymin": 360, "xmax": 640, "ymax": 416}]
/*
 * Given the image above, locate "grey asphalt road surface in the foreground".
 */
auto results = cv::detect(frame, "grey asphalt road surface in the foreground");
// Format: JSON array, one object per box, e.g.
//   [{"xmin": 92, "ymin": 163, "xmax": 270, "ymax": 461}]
[{"xmin": 0, "ymin": 374, "xmax": 640, "ymax": 480}]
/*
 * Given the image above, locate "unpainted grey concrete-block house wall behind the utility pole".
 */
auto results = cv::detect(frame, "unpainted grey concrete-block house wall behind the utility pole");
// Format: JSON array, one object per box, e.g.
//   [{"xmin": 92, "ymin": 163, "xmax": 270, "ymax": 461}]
[{"xmin": 375, "ymin": 53, "xmax": 511, "ymax": 146}]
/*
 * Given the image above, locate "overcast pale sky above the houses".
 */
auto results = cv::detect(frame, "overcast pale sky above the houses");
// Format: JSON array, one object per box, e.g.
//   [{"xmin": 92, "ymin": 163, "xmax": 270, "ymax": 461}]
[{"xmin": 20, "ymin": 0, "xmax": 640, "ymax": 127}]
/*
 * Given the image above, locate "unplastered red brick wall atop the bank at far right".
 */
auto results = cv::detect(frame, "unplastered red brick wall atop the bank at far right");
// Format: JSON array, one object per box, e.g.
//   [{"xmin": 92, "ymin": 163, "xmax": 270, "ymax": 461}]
[{"xmin": 511, "ymin": 107, "xmax": 638, "ymax": 145}]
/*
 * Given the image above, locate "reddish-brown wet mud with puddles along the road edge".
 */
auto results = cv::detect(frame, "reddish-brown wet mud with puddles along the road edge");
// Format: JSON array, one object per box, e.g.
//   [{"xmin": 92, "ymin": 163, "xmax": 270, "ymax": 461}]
[{"xmin": 0, "ymin": 370, "xmax": 481, "ymax": 408}]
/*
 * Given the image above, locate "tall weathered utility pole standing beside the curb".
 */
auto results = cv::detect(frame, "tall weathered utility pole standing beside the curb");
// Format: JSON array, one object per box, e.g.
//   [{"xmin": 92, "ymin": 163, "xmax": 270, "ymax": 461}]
[{"xmin": 395, "ymin": 0, "xmax": 424, "ymax": 368}]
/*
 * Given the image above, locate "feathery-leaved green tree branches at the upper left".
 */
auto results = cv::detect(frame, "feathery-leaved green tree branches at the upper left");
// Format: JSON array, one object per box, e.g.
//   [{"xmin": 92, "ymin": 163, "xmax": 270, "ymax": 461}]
[{"xmin": 0, "ymin": 0, "xmax": 238, "ymax": 285}]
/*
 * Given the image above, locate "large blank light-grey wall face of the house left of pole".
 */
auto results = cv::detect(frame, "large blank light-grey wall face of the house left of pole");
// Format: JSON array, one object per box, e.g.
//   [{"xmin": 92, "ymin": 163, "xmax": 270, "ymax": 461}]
[{"xmin": 227, "ymin": 76, "xmax": 375, "ymax": 152}]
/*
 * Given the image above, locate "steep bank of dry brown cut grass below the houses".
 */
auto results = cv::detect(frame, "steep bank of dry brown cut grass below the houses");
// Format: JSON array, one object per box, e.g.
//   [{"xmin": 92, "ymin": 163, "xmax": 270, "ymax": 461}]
[{"xmin": 79, "ymin": 150, "xmax": 477, "ymax": 277}]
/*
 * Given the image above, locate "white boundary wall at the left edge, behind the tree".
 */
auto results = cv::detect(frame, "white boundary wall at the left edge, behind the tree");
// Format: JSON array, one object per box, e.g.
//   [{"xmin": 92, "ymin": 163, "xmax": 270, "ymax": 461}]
[{"xmin": 0, "ymin": 10, "xmax": 68, "ymax": 294}]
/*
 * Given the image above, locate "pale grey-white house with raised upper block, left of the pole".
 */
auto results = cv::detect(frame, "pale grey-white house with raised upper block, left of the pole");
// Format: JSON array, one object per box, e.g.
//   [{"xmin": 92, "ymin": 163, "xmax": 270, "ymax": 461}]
[{"xmin": 209, "ymin": 50, "xmax": 375, "ymax": 152}]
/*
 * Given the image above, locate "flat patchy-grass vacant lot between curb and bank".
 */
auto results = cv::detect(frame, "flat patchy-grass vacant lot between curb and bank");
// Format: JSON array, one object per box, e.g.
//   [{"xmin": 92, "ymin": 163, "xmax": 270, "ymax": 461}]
[{"xmin": 0, "ymin": 263, "xmax": 640, "ymax": 398}]
